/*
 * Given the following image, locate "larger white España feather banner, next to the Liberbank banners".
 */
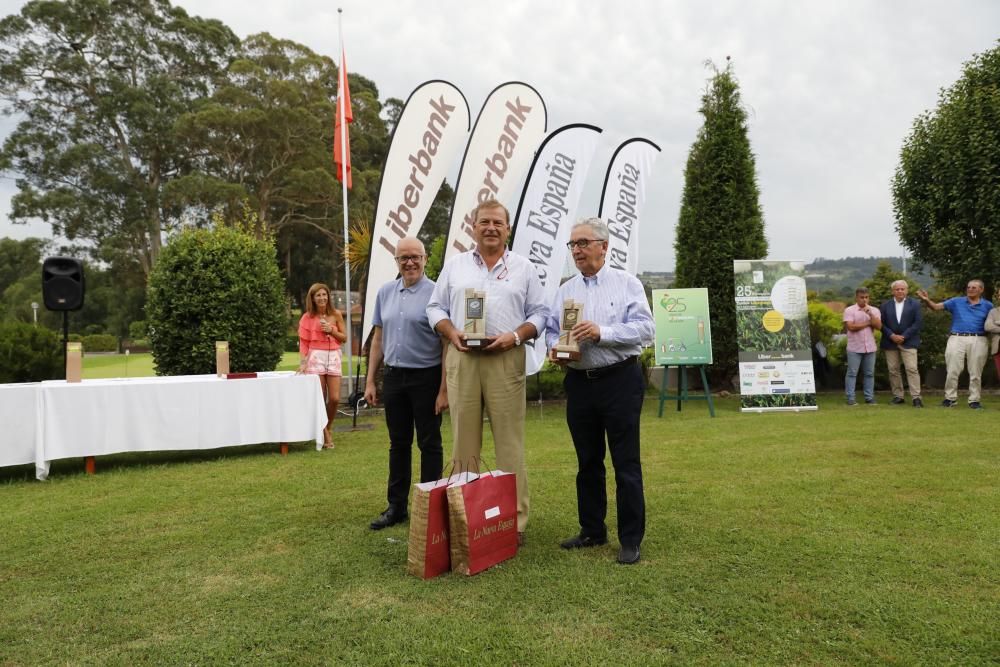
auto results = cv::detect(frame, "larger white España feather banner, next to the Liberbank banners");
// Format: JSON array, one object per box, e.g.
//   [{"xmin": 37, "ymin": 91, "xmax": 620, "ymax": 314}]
[{"xmin": 512, "ymin": 123, "xmax": 601, "ymax": 375}]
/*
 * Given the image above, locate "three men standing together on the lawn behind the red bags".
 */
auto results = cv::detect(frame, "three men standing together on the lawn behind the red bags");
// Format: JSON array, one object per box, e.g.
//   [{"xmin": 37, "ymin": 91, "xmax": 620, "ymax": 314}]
[{"xmin": 365, "ymin": 200, "xmax": 654, "ymax": 564}]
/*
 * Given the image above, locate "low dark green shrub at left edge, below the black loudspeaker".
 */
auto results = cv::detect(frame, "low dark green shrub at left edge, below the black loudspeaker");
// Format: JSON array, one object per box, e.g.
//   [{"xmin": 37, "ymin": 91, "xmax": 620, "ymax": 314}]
[{"xmin": 0, "ymin": 321, "xmax": 63, "ymax": 383}]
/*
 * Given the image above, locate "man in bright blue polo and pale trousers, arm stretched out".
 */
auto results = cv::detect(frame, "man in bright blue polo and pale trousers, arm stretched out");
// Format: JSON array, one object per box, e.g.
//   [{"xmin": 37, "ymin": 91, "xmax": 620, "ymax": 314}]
[{"xmin": 917, "ymin": 280, "xmax": 993, "ymax": 410}]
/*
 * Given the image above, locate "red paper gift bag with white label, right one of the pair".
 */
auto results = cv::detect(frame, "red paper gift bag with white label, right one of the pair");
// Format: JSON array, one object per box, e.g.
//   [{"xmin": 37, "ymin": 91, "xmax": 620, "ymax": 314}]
[{"xmin": 448, "ymin": 470, "xmax": 517, "ymax": 575}]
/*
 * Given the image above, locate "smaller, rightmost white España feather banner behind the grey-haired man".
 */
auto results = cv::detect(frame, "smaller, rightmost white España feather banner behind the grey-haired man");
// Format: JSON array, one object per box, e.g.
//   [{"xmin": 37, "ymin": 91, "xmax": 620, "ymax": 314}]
[{"xmin": 599, "ymin": 138, "xmax": 660, "ymax": 276}]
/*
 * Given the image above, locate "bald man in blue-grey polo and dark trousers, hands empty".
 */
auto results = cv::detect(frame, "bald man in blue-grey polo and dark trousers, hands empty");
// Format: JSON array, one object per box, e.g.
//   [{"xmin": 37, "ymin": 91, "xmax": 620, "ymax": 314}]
[{"xmin": 365, "ymin": 237, "xmax": 448, "ymax": 530}]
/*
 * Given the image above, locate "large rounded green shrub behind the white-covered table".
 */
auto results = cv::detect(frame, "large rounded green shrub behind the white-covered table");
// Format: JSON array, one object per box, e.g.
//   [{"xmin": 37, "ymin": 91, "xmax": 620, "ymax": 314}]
[{"xmin": 146, "ymin": 224, "xmax": 287, "ymax": 375}]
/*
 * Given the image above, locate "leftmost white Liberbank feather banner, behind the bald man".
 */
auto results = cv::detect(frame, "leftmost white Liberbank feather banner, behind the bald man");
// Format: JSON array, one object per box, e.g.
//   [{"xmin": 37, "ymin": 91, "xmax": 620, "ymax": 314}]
[{"xmin": 361, "ymin": 81, "xmax": 469, "ymax": 340}]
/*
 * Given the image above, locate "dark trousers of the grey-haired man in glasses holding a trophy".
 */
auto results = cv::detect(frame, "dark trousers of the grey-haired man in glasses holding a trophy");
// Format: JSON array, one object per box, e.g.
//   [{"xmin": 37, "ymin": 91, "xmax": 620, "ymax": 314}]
[{"xmin": 563, "ymin": 364, "xmax": 646, "ymax": 546}]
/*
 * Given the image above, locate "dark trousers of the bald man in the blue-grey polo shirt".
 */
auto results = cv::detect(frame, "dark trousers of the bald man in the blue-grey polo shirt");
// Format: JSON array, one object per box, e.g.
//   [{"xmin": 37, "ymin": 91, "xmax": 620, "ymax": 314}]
[{"xmin": 382, "ymin": 366, "xmax": 444, "ymax": 510}]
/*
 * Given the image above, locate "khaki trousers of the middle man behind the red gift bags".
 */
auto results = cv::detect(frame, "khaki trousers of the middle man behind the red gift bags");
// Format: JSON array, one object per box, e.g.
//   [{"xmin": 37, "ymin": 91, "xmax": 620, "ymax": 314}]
[{"xmin": 445, "ymin": 347, "xmax": 528, "ymax": 533}]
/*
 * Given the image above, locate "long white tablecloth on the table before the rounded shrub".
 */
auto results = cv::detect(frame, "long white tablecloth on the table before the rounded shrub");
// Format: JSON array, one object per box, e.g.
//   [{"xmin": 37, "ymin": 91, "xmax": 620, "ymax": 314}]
[{"xmin": 0, "ymin": 372, "xmax": 326, "ymax": 479}]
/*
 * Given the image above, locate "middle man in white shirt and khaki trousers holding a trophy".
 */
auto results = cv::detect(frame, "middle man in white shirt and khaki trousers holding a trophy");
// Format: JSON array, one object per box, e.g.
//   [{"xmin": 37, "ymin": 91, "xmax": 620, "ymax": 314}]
[{"xmin": 427, "ymin": 199, "xmax": 547, "ymax": 543}]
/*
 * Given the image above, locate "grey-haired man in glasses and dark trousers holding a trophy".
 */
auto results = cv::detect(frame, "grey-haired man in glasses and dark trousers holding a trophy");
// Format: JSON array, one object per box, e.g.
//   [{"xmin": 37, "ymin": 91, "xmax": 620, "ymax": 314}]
[{"xmin": 545, "ymin": 218, "xmax": 655, "ymax": 565}]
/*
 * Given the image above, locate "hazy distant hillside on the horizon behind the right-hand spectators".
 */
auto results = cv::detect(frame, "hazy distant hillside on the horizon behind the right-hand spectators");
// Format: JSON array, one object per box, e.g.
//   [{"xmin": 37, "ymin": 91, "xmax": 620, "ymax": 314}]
[{"xmin": 639, "ymin": 257, "xmax": 934, "ymax": 300}]
